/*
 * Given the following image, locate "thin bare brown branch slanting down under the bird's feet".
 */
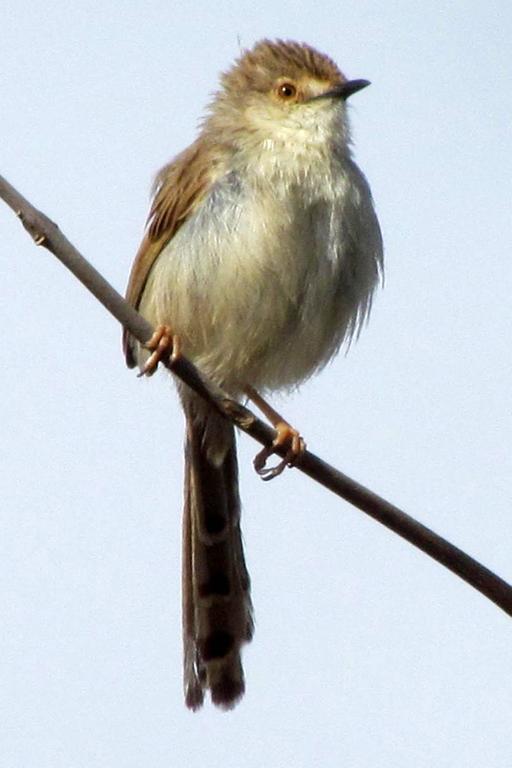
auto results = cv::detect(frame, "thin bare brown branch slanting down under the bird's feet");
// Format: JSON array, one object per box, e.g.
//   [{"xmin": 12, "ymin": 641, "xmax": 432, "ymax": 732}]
[{"xmin": 4, "ymin": 176, "xmax": 512, "ymax": 616}]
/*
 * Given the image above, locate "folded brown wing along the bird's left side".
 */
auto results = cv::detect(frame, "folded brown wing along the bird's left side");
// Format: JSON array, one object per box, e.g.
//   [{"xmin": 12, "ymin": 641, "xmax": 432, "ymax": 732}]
[{"xmin": 123, "ymin": 138, "xmax": 218, "ymax": 368}]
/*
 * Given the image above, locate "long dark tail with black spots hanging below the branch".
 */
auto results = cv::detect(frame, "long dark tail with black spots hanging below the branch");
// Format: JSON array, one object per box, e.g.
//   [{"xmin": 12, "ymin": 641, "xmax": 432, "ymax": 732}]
[{"xmin": 183, "ymin": 404, "xmax": 253, "ymax": 709}]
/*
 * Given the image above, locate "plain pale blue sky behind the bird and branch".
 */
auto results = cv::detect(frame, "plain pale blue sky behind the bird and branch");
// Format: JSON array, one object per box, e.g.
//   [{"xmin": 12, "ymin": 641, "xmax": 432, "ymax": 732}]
[{"xmin": 0, "ymin": 0, "xmax": 512, "ymax": 768}]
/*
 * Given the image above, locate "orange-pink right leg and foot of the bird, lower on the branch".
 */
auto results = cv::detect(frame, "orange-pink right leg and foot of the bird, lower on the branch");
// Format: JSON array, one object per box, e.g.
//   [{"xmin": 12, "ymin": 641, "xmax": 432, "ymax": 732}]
[{"xmin": 244, "ymin": 386, "xmax": 306, "ymax": 480}]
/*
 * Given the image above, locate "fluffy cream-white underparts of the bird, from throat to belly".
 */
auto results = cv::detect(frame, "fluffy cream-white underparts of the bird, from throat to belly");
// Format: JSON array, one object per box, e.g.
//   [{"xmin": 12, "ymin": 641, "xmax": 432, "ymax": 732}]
[{"xmin": 140, "ymin": 103, "xmax": 382, "ymax": 392}]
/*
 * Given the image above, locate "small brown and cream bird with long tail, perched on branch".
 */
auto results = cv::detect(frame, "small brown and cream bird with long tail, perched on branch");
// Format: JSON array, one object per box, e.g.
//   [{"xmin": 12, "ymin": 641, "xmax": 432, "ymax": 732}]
[{"xmin": 124, "ymin": 40, "xmax": 382, "ymax": 710}]
